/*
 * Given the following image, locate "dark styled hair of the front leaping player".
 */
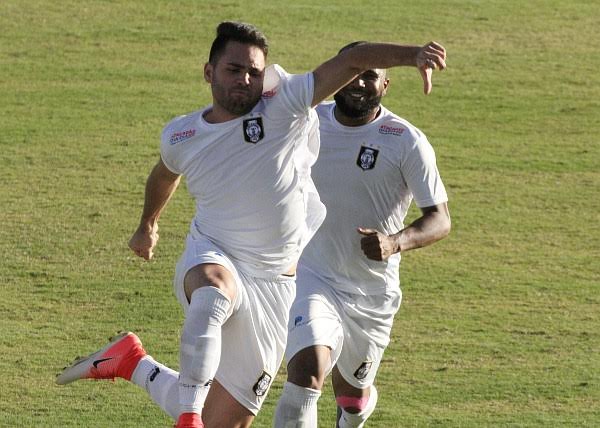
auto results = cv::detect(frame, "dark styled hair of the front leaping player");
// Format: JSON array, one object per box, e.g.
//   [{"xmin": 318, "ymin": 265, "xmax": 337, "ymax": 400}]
[{"xmin": 208, "ymin": 21, "xmax": 269, "ymax": 64}]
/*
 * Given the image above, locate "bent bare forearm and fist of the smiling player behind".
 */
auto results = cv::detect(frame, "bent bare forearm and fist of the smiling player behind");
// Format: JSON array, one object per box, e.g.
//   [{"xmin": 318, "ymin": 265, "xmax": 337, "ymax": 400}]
[{"xmin": 358, "ymin": 203, "xmax": 451, "ymax": 261}]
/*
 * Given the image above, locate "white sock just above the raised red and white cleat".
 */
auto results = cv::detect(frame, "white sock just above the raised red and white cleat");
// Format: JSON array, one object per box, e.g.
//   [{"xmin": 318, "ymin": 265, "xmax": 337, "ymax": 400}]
[{"xmin": 131, "ymin": 355, "xmax": 179, "ymax": 419}]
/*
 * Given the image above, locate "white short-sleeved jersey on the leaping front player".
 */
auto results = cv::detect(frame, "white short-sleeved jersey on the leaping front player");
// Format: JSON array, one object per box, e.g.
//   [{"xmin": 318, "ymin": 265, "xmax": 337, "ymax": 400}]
[{"xmin": 161, "ymin": 66, "xmax": 325, "ymax": 276}]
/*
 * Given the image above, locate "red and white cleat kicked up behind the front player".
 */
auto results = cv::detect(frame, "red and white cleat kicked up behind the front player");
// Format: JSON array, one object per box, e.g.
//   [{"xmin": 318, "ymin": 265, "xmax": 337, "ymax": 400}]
[{"xmin": 56, "ymin": 332, "xmax": 146, "ymax": 385}]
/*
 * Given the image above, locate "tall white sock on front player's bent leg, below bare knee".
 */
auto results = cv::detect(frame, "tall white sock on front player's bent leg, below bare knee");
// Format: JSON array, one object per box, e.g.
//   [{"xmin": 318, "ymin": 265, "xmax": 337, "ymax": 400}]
[{"xmin": 179, "ymin": 286, "xmax": 231, "ymax": 413}]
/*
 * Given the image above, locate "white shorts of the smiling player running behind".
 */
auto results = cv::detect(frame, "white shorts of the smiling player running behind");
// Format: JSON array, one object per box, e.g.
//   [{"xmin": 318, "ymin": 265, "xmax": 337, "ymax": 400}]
[{"xmin": 285, "ymin": 267, "xmax": 402, "ymax": 389}]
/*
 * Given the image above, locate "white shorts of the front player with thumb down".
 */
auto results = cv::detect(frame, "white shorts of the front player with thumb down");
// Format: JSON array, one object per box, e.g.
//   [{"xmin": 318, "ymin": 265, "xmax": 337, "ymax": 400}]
[{"xmin": 174, "ymin": 236, "xmax": 295, "ymax": 415}]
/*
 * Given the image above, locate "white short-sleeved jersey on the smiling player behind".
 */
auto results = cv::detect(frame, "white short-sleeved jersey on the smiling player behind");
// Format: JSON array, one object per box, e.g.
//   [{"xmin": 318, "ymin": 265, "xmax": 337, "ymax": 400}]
[{"xmin": 298, "ymin": 102, "xmax": 448, "ymax": 295}]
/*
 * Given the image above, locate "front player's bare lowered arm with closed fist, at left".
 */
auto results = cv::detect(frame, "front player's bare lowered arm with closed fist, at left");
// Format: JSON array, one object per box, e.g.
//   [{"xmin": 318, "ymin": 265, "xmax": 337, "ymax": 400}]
[{"xmin": 129, "ymin": 159, "xmax": 181, "ymax": 260}]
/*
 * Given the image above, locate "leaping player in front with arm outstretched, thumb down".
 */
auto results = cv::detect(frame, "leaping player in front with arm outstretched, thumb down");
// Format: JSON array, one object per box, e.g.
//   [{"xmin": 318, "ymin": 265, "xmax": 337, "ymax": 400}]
[{"xmin": 57, "ymin": 26, "xmax": 446, "ymax": 428}]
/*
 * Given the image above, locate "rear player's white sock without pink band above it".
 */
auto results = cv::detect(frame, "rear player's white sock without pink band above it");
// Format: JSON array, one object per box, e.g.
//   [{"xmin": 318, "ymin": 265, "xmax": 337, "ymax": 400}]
[{"xmin": 273, "ymin": 382, "xmax": 321, "ymax": 428}]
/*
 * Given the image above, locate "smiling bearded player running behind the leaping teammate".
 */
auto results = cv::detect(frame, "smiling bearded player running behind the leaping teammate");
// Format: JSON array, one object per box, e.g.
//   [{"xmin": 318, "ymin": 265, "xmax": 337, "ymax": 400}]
[{"xmin": 275, "ymin": 42, "xmax": 450, "ymax": 428}]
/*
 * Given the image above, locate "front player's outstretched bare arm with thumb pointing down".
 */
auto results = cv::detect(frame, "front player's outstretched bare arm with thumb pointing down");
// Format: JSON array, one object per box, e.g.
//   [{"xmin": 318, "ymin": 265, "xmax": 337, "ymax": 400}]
[{"xmin": 312, "ymin": 42, "xmax": 446, "ymax": 107}]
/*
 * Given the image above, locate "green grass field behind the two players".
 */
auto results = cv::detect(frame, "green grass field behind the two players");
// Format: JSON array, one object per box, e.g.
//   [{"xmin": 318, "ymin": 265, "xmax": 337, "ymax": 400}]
[{"xmin": 0, "ymin": 0, "xmax": 600, "ymax": 427}]
